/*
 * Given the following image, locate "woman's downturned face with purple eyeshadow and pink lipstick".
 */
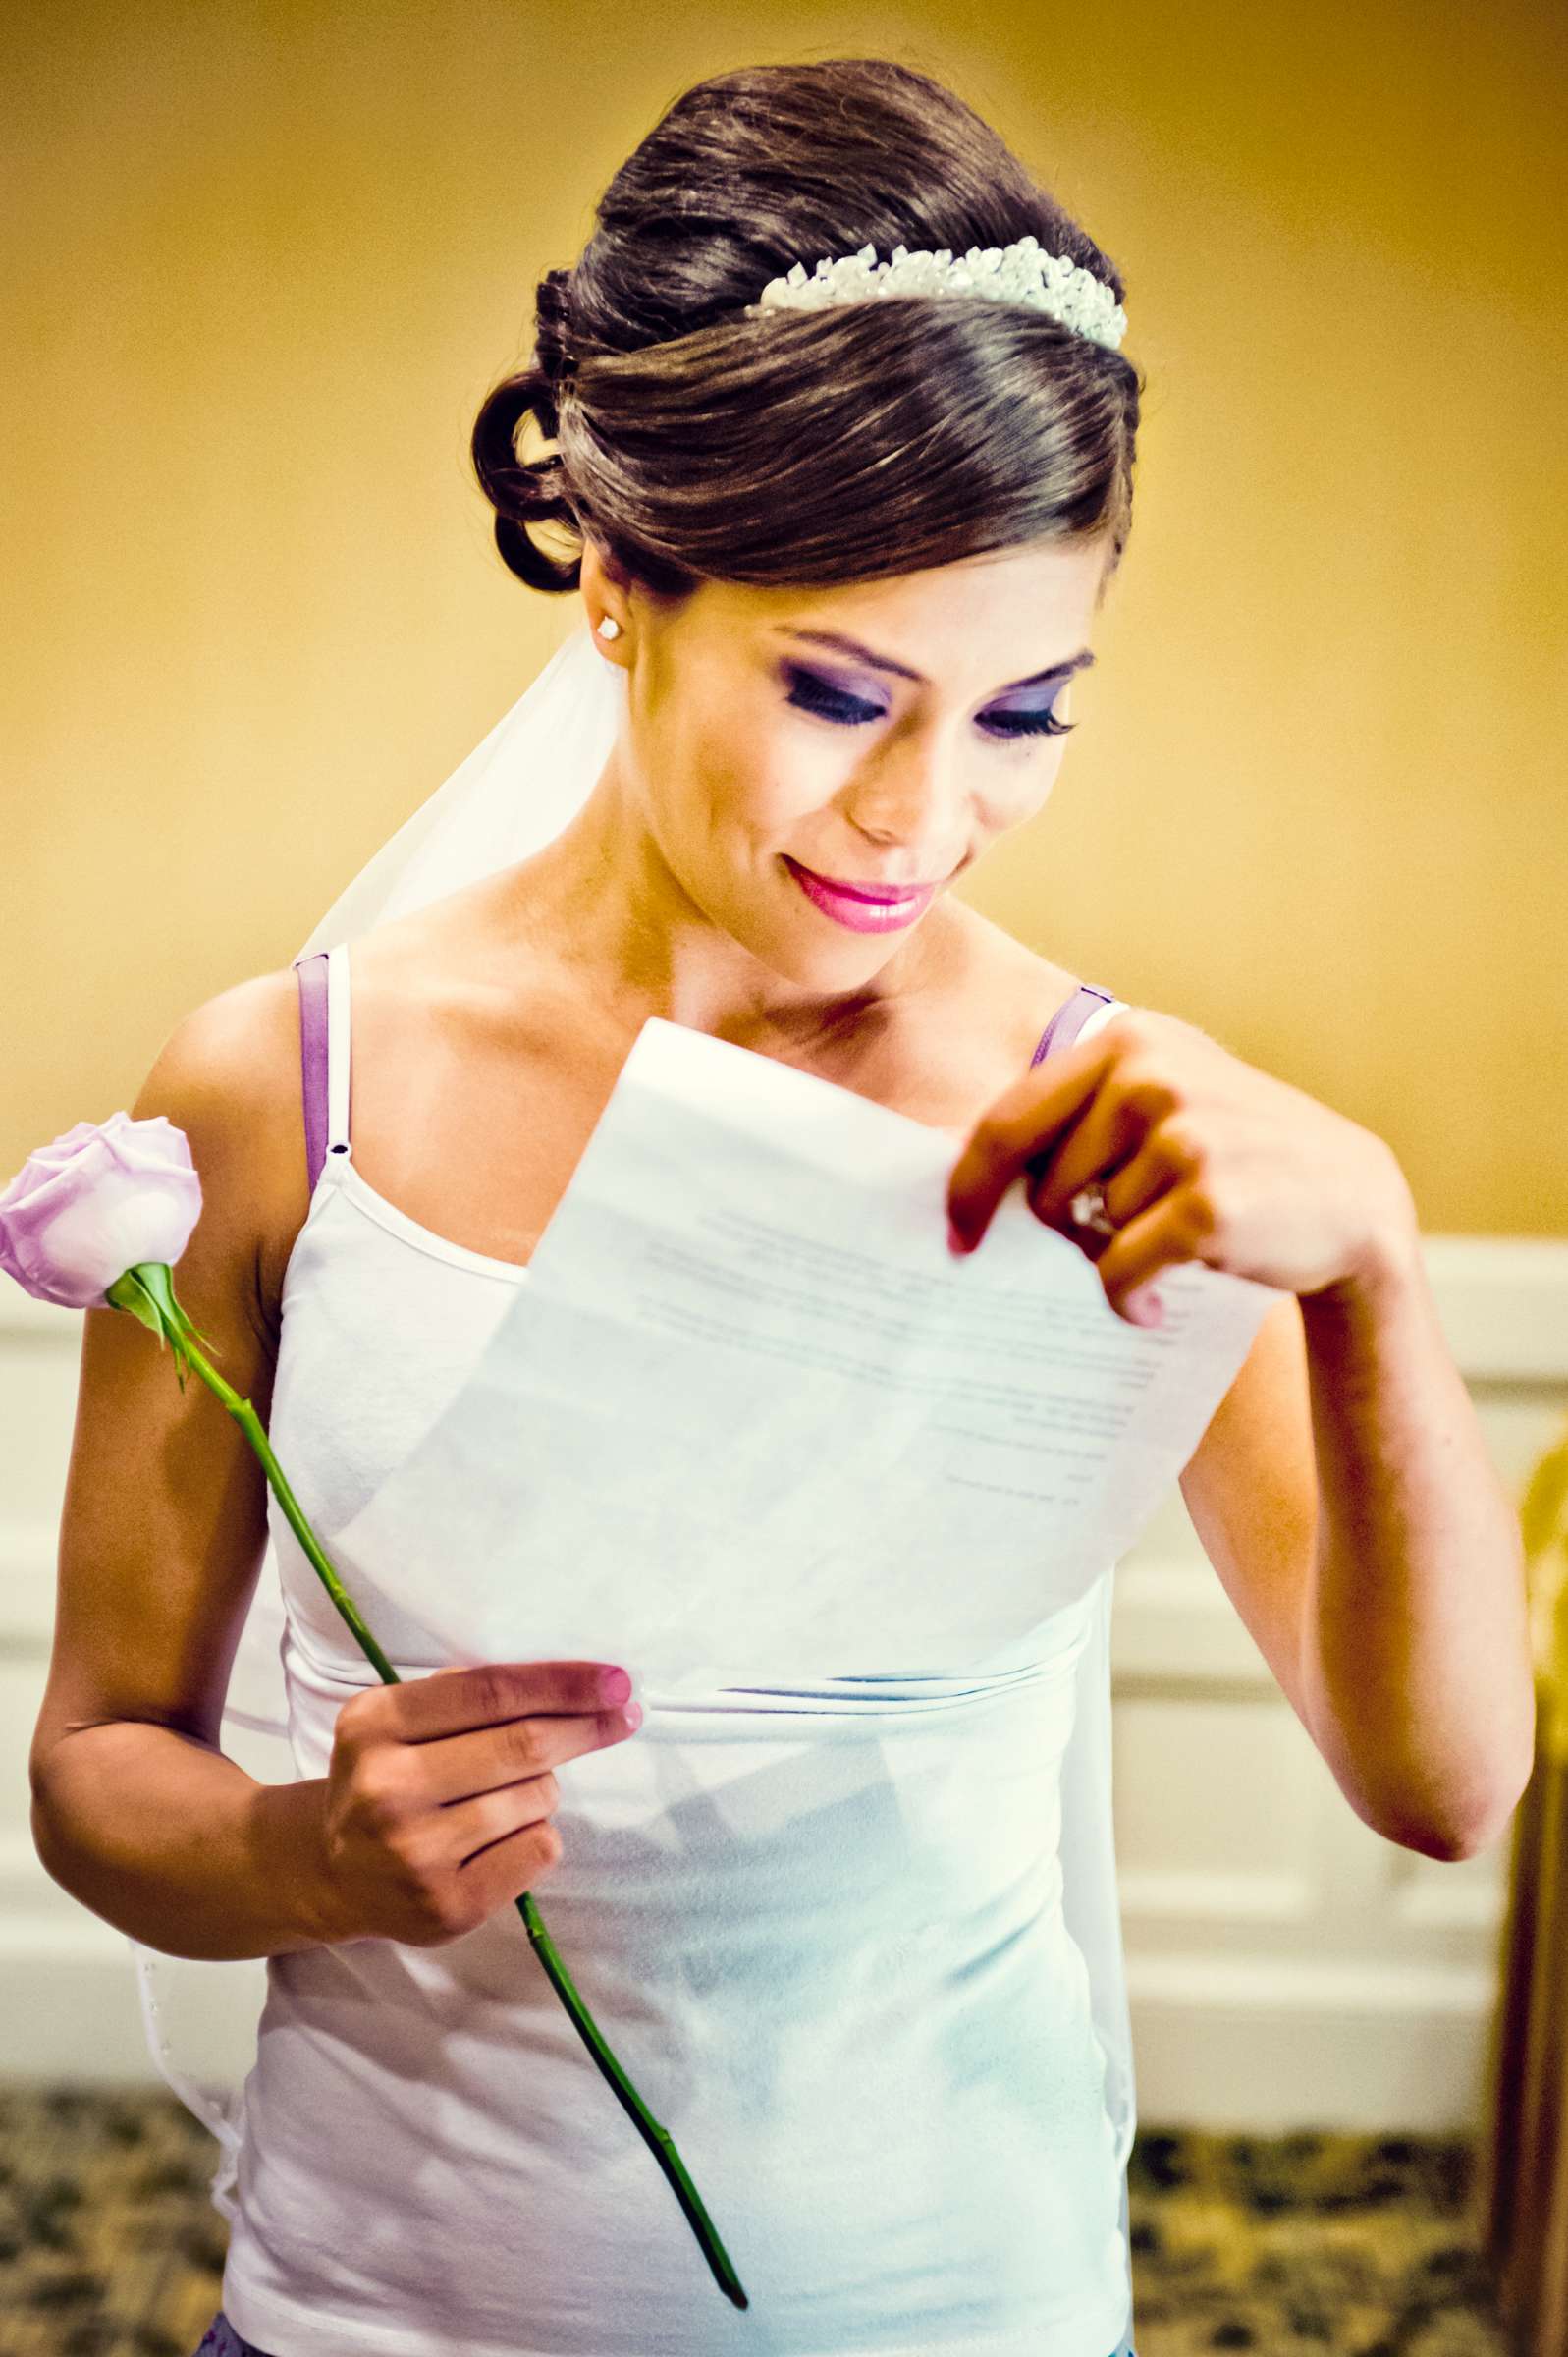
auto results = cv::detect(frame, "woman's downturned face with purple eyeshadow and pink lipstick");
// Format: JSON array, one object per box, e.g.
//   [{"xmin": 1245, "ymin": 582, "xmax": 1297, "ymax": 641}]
[{"xmin": 582, "ymin": 540, "xmax": 1106, "ymax": 990}]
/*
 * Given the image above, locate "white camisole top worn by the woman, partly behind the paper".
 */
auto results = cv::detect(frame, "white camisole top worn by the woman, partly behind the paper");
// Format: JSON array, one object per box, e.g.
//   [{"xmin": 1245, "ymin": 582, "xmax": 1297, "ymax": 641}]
[{"xmin": 210, "ymin": 943, "xmax": 1134, "ymax": 2357}]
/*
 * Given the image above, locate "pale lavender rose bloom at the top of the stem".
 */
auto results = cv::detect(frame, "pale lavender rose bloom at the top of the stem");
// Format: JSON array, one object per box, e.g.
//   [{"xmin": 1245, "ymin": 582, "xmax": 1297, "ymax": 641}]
[{"xmin": 0, "ymin": 1113, "xmax": 200, "ymax": 1310}]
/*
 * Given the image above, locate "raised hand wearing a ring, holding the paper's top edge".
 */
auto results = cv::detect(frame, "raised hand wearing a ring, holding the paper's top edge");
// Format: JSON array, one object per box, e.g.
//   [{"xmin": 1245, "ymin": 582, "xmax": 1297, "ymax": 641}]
[{"xmin": 947, "ymin": 1007, "xmax": 1417, "ymax": 1325}]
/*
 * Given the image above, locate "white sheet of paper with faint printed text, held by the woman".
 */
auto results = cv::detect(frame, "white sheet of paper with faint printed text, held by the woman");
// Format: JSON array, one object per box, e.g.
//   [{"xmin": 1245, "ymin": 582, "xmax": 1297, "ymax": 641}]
[{"xmin": 323, "ymin": 1018, "xmax": 1282, "ymax": 1692}]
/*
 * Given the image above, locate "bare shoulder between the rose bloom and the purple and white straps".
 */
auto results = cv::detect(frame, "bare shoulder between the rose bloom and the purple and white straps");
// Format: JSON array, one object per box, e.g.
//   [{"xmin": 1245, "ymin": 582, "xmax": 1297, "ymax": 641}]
[{"xmin": 132, "ymin": 966, "xmax": 309, "ymax": 1332}]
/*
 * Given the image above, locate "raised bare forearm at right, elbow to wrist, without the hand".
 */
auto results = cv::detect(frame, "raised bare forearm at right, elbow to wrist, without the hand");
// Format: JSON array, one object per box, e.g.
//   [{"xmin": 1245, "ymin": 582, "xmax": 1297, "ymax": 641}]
[{"xmin": 1181, "ymin": 1219, "xmax": 1535, "ymax": 1860}]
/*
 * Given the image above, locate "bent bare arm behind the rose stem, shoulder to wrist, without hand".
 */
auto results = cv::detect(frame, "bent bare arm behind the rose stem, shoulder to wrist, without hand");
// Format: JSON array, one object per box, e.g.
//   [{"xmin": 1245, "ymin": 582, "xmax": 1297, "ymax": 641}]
[{"xmin": 28, "ymin": 968, "xmax": 349, "ymax": 1956}]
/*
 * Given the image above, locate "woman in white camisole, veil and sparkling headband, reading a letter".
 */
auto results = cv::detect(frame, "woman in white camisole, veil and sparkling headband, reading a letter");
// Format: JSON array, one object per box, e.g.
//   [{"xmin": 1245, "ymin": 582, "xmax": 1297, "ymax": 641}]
[{"xmin": 33, "ymin": 41, "xmax": 1528, "ymax": 2357}]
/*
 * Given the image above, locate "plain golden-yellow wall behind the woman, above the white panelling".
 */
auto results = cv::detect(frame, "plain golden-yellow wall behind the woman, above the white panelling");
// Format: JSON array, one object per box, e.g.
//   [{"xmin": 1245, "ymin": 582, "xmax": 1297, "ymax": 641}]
[{"xmin": 0, "ymin": 0, "xmax": 1568, "ymax": 1235}]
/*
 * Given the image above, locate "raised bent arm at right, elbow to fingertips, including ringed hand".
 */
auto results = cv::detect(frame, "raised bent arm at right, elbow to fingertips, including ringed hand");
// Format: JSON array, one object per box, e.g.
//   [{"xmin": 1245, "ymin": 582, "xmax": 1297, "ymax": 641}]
[{"xmin": 947, "ymin": 1007, "xmax": 1535, "ymax": 1857}]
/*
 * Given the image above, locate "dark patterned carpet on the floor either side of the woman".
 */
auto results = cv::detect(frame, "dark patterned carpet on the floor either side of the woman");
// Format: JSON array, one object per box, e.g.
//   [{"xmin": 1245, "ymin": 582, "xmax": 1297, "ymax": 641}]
[{"xmin": 0, "ymin": 2088, "xmax": 1507, "ymax": 2357}]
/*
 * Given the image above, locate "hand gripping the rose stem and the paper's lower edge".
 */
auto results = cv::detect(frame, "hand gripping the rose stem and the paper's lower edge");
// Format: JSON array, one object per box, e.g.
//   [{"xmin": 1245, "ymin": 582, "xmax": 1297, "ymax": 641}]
[{"xmin": 323, "ymin": 1662, "xmax": 641, "ymax": 1946}]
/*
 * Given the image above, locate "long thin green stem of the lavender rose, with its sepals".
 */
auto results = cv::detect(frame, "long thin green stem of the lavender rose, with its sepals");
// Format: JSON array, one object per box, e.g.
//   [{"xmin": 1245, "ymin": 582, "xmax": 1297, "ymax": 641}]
[{"xmin": 104, "ymin": 1261, "xmax": 750, "ymax": 2308}]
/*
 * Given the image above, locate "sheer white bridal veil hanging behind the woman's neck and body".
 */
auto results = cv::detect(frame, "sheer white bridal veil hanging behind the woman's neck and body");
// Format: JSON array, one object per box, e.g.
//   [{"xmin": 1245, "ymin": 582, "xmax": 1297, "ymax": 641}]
[{"xmin": 130, "ymin": 625, "xmax": 1134, "ymax": 2357}]
